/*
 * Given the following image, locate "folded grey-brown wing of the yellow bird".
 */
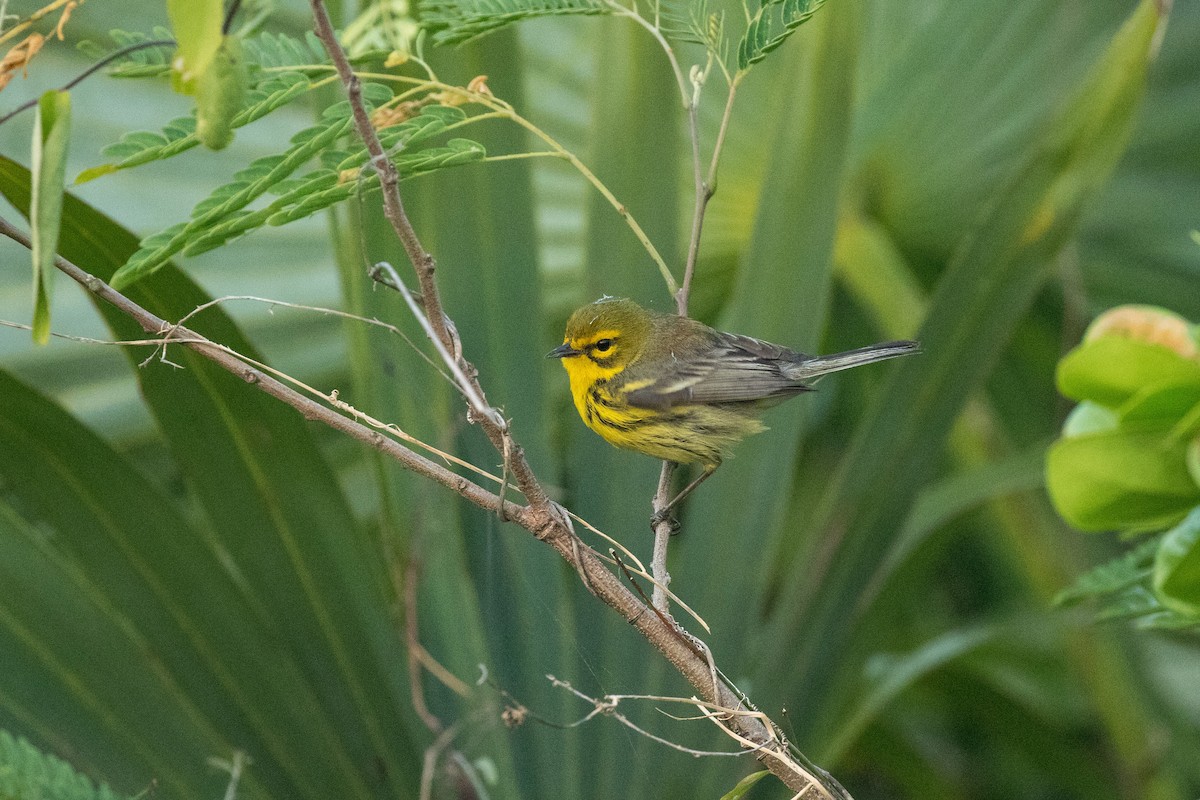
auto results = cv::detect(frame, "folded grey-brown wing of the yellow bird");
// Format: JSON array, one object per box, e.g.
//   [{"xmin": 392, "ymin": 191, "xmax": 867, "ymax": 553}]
[{"xmin": 625, "ymin": 333, "xmax": 806, "ymax": 409}]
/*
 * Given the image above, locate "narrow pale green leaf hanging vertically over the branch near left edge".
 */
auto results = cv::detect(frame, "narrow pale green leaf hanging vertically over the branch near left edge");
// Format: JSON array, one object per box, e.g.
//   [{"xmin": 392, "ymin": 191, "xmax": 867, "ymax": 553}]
[{"xmin": 30, "ymin": 90, "xmax": 71, "ymax": 344}]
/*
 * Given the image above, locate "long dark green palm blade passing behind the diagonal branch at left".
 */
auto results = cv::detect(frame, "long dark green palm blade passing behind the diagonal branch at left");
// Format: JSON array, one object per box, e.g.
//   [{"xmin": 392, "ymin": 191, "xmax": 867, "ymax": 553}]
[{"xmin": 0, "ymin": 154, "xmax": 420, "ymax": 800}]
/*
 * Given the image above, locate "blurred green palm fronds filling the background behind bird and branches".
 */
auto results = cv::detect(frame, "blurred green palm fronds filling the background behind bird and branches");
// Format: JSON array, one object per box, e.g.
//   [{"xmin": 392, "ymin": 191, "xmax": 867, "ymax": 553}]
[{"xmin": 0, "ymin": 0, "xmax": 1200, "ymax": 800}]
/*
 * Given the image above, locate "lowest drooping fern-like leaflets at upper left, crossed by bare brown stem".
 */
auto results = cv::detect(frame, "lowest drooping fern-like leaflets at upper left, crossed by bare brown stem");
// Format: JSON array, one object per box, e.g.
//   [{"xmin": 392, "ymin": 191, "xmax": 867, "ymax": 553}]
[{"xmin": 113, "ymin": 99, "xmax": 487, "ymax": 288}]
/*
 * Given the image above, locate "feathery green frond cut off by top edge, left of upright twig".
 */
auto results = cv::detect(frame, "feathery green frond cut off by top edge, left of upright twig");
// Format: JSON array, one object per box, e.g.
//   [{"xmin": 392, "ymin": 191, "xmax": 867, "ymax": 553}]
[{"xmin": 421, "ymin": 0, "xmax": 613, "ymax": 44}]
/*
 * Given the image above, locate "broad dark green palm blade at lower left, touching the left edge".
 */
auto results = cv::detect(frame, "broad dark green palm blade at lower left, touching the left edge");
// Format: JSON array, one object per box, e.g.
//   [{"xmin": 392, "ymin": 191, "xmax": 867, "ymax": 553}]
[{"xmin": 0, "ymin": 371, "xmax": 260, "ymax": 794}]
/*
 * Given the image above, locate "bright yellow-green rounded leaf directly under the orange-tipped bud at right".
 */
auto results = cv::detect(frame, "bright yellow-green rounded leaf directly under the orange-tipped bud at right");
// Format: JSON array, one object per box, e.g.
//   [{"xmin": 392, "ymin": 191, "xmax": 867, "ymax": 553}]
[{"xmin": 1056, "ymin": 336, "xmax": 1200, "ymax": 408}]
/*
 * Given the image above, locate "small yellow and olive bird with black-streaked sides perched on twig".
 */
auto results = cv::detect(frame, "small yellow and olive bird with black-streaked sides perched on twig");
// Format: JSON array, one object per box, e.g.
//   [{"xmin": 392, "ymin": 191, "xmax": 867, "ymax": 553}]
[{"xmin": 546, "ymin": 296, "xmax": 920, "ymax": 518}]
